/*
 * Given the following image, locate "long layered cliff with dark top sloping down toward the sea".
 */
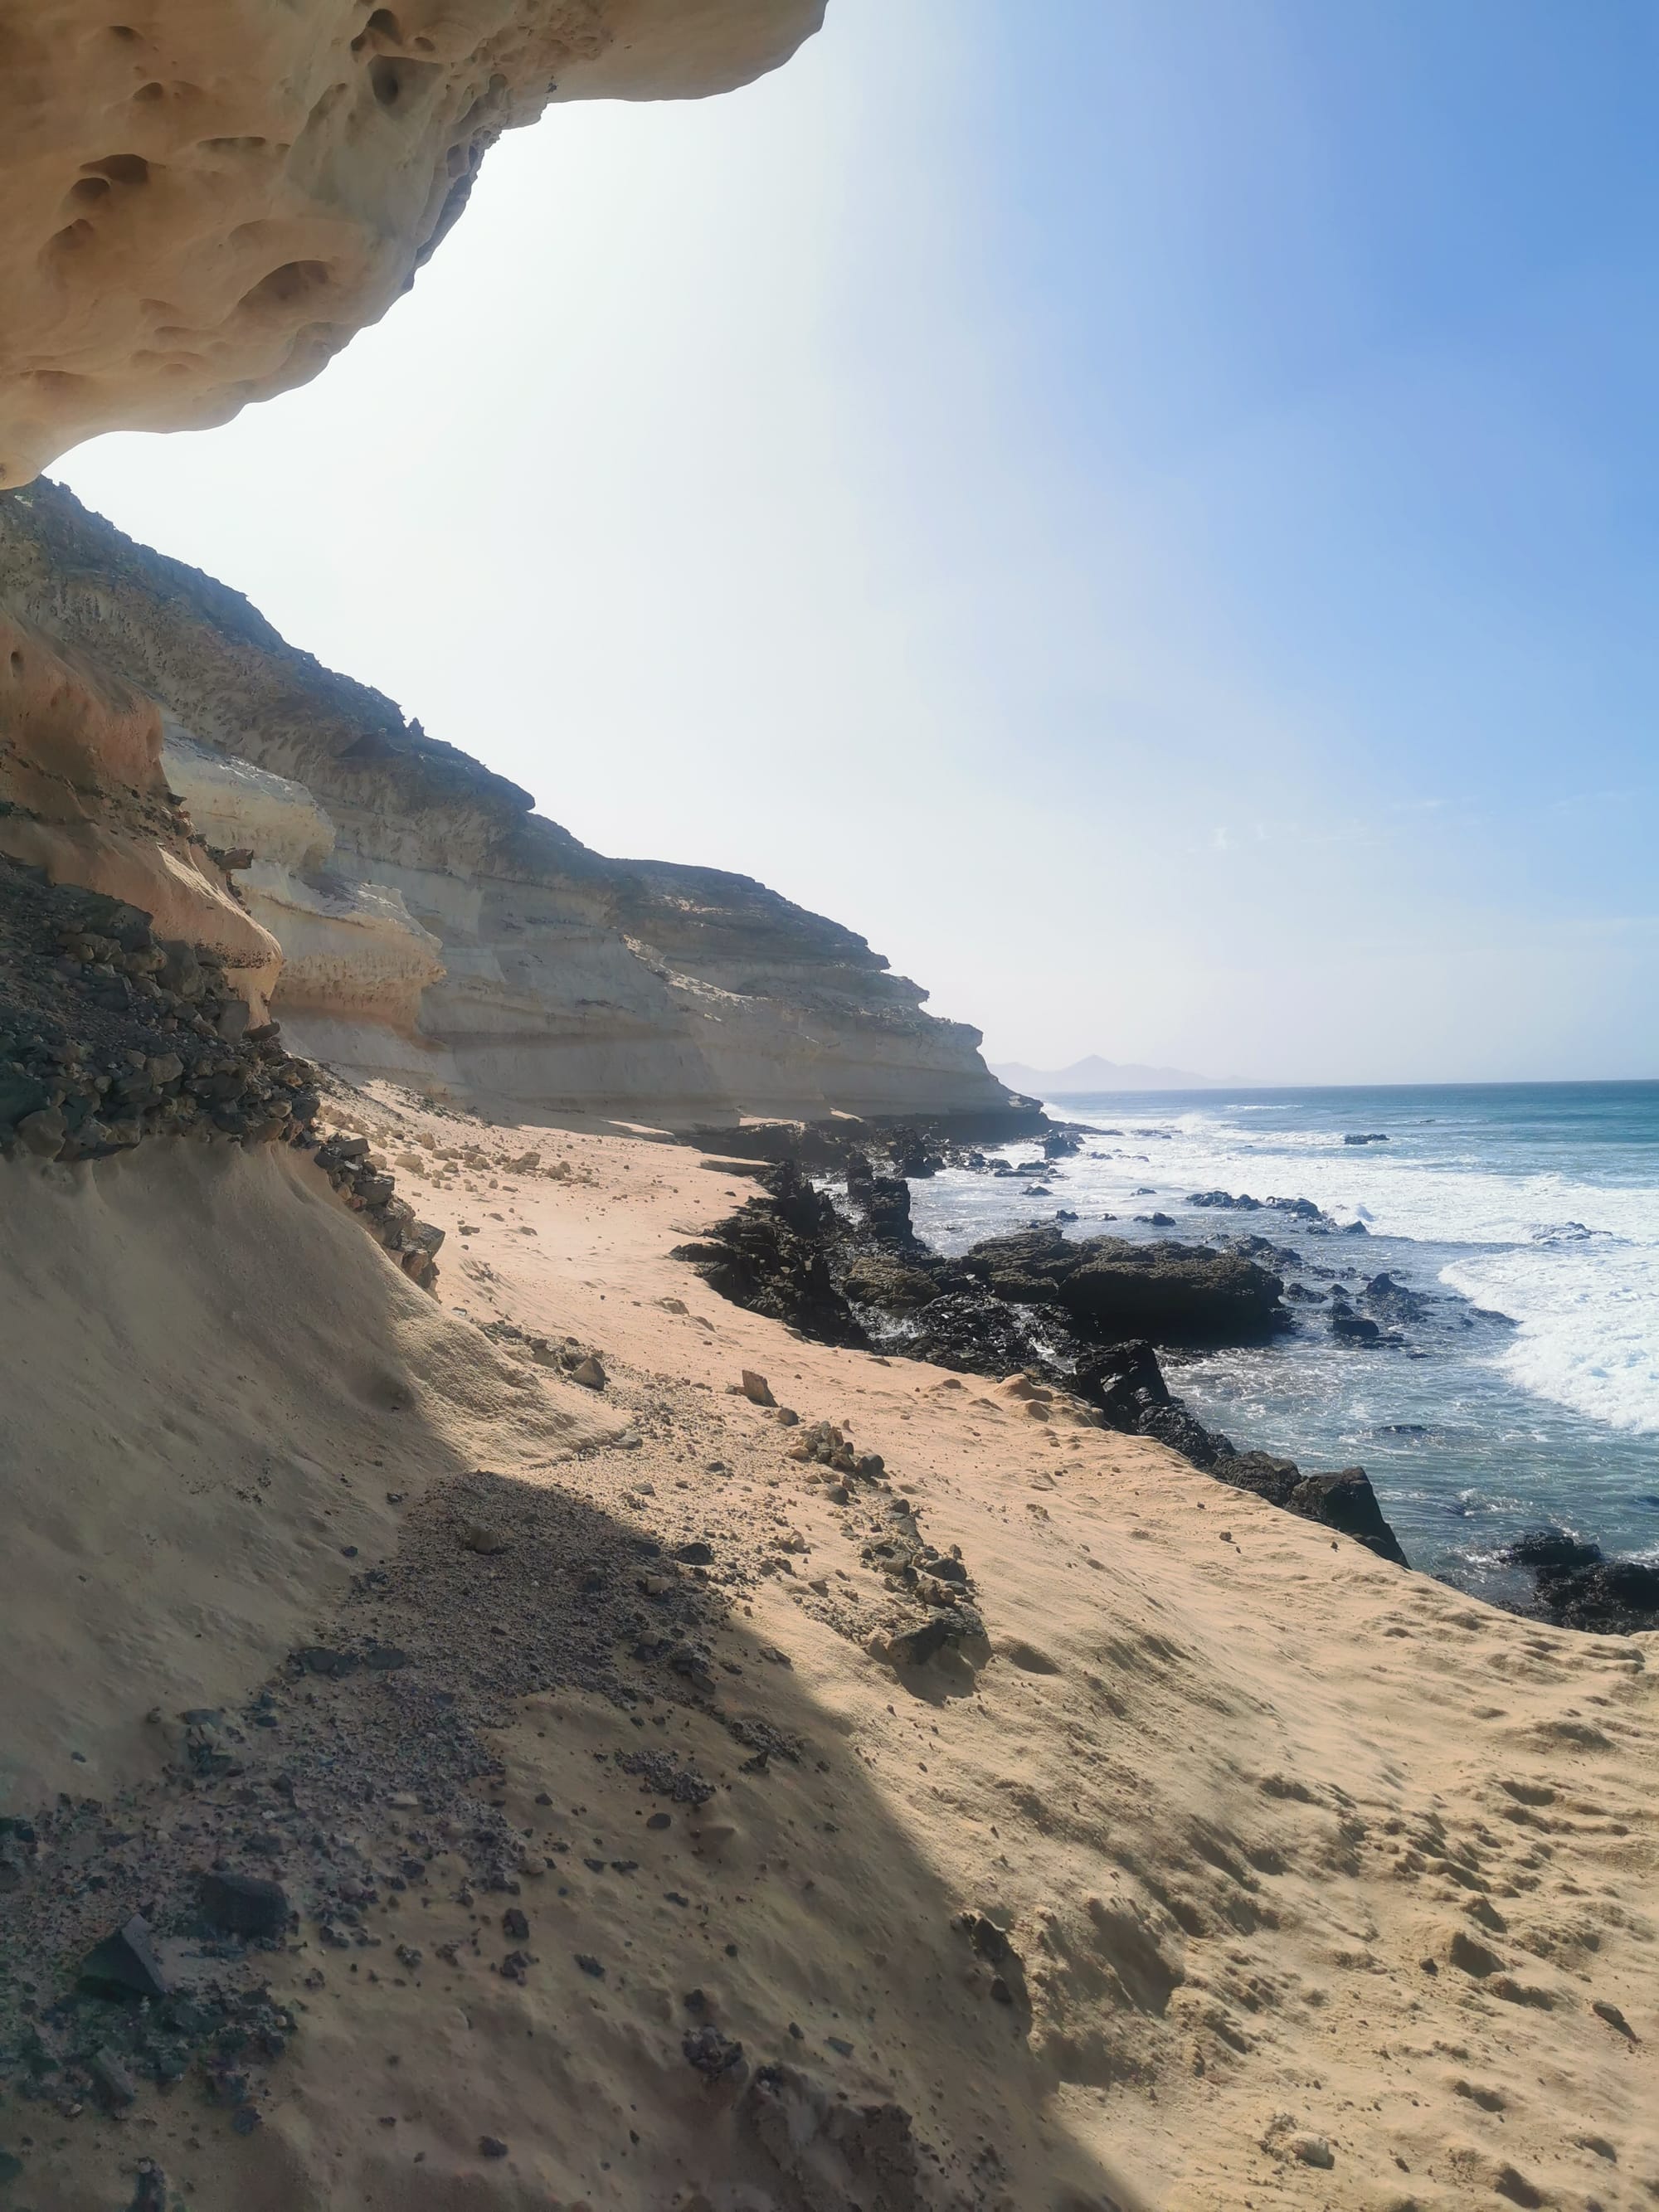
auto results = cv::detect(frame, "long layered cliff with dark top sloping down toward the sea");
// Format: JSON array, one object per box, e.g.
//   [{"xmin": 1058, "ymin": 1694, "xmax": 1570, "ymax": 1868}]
[{"xmin": 0, "ymin": 482, "xmax": 1009, "ymax": 1126}]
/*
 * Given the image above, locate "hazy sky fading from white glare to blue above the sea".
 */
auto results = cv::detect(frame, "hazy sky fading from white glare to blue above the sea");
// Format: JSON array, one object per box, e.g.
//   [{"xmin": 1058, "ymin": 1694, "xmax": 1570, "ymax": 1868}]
[{"xmin": 60, "ymin": 0, "xmax": 1659, "ymax": 1082}]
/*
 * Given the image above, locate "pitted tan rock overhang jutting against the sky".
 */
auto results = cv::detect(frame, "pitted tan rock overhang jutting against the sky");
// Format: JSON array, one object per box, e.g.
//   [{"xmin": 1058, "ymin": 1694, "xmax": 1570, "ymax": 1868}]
[{"xmin": 0, "ymin": 0, "xmax": 823, "ymax": 487}]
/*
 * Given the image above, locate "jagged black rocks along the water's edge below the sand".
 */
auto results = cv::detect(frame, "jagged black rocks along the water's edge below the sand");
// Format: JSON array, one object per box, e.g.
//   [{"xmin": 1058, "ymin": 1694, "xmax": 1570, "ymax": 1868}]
[{"xmin": 674, "ymin": 1108, "xmax": 1659, "ymax": 1635}]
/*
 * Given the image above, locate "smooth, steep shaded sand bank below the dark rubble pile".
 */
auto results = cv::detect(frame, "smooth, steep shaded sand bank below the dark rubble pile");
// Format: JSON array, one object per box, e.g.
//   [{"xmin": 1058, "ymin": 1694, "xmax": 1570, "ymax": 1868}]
[{"xmin": 0, "ymin": 1141, "xmax": 611, "ymax": 1810}]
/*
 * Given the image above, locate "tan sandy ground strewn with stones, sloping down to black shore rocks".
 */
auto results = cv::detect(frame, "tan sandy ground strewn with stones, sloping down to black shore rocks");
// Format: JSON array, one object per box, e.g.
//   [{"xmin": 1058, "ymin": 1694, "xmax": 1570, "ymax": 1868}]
[{"xmin": 0, "ymin": 1095, "xmax": 1659, "ymax": 2212}]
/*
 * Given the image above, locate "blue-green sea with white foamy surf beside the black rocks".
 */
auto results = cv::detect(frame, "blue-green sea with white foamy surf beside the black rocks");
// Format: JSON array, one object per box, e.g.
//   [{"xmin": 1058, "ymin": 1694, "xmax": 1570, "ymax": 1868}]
[{"xmin": 912, "ymin": 1084, "xmax": 1659, "ymax": 1597}]
